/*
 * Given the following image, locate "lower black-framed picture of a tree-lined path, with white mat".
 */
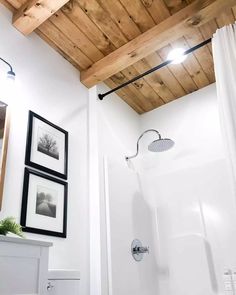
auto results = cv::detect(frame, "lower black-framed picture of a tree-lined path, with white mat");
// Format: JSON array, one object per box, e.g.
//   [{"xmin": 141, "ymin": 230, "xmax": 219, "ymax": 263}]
[{"xmin": 21, "ymin": 168, "xmax": 67, "ymax": 238}]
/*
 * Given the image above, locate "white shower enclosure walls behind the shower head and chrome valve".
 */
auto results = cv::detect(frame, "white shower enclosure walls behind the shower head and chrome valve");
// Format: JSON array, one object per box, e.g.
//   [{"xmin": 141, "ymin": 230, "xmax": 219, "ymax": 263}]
[{"xmin": 99, "ymin": 85, "xmax": 236, "ymax": 295}]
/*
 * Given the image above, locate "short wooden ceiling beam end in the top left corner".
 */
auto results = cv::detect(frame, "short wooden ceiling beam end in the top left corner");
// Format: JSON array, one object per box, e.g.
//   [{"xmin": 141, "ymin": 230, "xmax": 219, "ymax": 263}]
[{"xmin": 13, "ymin": 0, "xmax": 69, "ymax": 35}]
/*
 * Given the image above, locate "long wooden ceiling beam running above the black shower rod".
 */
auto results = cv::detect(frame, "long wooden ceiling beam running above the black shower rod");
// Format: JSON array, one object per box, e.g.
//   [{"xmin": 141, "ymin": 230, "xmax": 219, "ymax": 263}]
[{"xmin": 81, "ymin": 0, "xmax": 236, "ymax": 87}]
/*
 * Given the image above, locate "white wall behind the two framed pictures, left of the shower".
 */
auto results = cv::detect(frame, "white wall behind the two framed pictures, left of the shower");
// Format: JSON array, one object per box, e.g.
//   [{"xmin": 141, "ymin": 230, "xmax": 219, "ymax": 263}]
[{"xmin": 0, "ymin": 6, "xmax": 89, "ymax": 295}]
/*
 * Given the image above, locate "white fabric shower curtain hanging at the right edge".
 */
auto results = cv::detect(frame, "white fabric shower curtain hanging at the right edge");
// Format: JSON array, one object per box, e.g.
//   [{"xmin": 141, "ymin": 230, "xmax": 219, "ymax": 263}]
[{"xmin": 212, "ymin": 24, "xmax": 236, "ymax": 182}]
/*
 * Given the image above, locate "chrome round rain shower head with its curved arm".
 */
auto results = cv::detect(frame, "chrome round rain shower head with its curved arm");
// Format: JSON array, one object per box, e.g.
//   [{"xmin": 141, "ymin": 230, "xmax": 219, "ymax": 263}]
[{"xmin": 125, "ymin": 129, "xmax": 175, "ymax": 160}]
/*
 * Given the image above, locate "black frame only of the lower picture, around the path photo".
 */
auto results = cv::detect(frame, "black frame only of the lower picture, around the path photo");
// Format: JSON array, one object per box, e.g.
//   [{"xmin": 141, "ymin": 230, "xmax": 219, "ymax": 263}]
[{"xmin": 20, "ymin": 168, "xmax": 68, "ymax": 238}]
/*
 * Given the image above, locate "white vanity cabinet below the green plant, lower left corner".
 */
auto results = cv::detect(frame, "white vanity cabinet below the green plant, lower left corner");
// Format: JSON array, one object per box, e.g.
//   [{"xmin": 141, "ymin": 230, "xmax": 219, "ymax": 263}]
[{"xmin": 0, "ymin": 236, "xmax": 52, "ymax": 295}]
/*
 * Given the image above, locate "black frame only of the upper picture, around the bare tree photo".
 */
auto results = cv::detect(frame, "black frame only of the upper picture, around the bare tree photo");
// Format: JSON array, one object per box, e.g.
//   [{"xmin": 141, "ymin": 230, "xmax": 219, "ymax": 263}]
[{"xmin": 25, "ymin": 111, "xmax": 68, "ymax": 180}]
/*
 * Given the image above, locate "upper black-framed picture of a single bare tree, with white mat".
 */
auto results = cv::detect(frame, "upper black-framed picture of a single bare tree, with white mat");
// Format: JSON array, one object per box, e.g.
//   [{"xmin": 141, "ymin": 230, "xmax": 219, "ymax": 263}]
[{"xmin": 25, "ymin": 111, "xmax": 68, "ymax": 179}]
